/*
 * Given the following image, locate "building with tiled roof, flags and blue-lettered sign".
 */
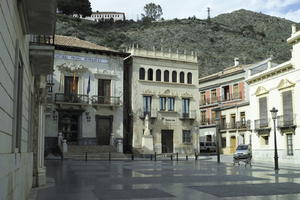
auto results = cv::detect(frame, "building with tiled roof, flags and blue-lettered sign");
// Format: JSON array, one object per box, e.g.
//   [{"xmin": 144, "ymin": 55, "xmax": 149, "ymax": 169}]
[{"xmin": 45, "ymin": 36, "xmax": 129, "ymax": 154}]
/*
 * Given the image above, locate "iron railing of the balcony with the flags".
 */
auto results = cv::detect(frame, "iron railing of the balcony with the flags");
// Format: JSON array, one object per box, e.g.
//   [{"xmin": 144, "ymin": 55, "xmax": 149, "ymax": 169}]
[{"xmin": 54, "ymin": 93, "xmax": 89, "ymax": 104}]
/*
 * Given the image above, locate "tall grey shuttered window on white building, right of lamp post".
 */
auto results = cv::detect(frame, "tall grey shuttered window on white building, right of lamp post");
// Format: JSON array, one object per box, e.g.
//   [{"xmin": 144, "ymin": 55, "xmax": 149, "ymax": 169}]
[{"xmin": 282, "ymin": 91, "xmax": 293, "ymax": 125}]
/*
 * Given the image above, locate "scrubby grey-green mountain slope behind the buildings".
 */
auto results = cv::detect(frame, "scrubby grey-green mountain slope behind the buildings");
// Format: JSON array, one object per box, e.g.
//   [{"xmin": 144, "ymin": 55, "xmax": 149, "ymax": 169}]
[{"xmin": 56, "ymin": 9, "xmax": 299, "ymax": 76}]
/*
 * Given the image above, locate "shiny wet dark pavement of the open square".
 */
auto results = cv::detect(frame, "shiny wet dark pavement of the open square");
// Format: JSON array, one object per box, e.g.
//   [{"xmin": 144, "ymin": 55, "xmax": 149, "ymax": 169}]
[{"xmin": 36, "ymin": 160, "xmax": 300, "ymax": 200}]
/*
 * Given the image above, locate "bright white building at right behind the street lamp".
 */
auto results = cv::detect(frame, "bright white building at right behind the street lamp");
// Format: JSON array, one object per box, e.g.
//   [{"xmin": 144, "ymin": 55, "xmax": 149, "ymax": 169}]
[{"xmin": 246, "ymin": 26, "xmax": 300, "ymax": 164}]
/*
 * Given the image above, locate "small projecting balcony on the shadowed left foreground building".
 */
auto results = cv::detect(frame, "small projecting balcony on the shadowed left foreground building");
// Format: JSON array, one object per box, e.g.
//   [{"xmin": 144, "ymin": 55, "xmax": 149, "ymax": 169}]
[{"xmin": 29, "ymin": 35, "xmax": 55, "ymax": 75}]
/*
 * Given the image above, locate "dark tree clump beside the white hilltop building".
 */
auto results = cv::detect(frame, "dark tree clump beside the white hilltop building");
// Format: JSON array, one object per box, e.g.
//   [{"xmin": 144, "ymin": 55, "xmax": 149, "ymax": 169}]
[{"xmin": 57, "ymin": 0, "xmax": 92, "ymax": 17}]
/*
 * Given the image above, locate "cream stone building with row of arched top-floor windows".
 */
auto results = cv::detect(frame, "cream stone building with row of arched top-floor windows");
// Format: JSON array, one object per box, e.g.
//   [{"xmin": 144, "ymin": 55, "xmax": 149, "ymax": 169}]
[{"xmin": 124, "ymin": 47, "xmax": 199, "ymax": 154}]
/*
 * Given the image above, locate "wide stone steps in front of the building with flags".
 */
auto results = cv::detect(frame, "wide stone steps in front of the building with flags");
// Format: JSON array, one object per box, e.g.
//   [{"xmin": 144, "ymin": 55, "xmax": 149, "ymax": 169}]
[{"xmin": 64, "ymin": 145, "xmax": 126, "ymax": 160}]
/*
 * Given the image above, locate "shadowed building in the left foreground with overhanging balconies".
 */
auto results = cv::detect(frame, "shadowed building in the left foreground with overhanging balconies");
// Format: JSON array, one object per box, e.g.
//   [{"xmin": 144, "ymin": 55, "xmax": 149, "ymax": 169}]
[{"xmin": 0, "ymin": 0, "xmax": 56, "ymax": 200}]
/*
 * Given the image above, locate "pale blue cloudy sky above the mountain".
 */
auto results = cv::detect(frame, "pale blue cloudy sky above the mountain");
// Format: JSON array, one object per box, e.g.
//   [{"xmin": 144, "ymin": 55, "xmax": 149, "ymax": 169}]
[{"xmin": 90, "ymin": 0, "xmax": 300, "ymax": 22}]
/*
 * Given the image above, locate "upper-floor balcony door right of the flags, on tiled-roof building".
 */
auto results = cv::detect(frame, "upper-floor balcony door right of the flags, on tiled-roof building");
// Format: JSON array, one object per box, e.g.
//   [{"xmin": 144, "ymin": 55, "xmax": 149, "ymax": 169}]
[{"xmin": 98, "ymin": 79, "xmax": 111, "ymax": 104}]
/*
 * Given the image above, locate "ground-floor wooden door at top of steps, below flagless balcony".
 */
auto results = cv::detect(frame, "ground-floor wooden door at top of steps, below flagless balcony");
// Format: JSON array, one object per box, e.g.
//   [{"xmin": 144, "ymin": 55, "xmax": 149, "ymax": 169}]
[{"xmin": 96, "ymin": 116, "xmax": 112, "ymax": 145}]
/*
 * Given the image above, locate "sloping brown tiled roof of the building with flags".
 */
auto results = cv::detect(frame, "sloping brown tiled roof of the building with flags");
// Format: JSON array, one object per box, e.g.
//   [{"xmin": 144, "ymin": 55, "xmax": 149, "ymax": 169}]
[{"xmin": 54, "ymin": 35, "xmax": 117, "ymax": 52}]
